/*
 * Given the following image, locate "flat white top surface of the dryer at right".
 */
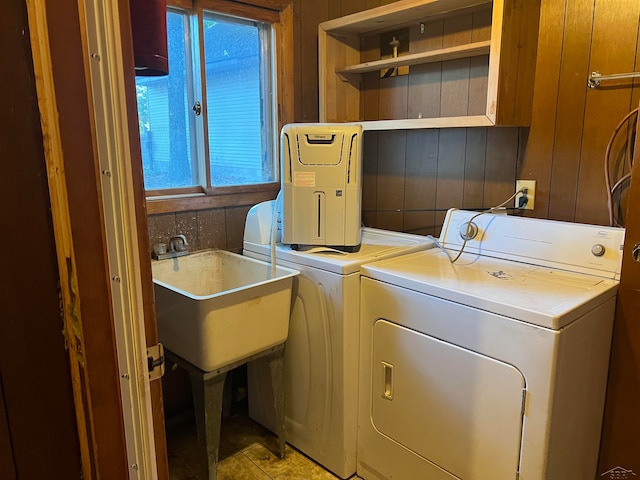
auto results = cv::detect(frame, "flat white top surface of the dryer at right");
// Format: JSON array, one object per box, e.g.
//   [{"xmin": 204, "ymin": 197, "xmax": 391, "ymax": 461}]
[{"xmin": 361, "ymin": 249, "xmax": 618, "ymax": 329}]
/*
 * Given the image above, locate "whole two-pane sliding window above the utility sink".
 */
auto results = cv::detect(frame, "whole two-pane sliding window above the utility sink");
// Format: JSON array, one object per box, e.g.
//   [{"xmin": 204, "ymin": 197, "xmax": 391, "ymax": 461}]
[{"xmin": 136, "ymin": 1, "xmax": 279, "ymax": 206}]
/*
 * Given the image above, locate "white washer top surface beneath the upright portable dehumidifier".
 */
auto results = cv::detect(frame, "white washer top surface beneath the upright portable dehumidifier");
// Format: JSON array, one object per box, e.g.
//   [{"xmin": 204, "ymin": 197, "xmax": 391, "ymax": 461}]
[{"xmin": 244, "ymin": 227, "xmax": 433, "ymax": 275}]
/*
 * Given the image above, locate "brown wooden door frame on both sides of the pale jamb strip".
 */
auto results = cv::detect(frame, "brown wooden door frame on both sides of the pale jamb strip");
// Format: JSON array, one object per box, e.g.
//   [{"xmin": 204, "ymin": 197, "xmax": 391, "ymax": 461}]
[{"xmin": 22, "ymin": 0, "xmax": 168, "ymax": 480}]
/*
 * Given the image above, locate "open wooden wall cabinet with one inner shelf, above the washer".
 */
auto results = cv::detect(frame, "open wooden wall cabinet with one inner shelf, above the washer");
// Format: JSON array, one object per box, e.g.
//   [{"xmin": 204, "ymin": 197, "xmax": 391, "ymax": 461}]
[{"xmin": 318, "ymin": 0, "xmax": 540, "ymax": 130}]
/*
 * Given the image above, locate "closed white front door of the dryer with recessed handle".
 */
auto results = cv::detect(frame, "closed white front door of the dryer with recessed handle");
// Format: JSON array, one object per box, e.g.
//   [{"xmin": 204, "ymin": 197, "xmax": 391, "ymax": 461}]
[{"xmin": 371, "ymin": 320, "xmax": 526, "ymax": 480}]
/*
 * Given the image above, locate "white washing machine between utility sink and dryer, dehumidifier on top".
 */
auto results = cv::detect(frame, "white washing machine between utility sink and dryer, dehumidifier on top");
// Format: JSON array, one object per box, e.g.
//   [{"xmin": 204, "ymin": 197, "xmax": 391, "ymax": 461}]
[{"xmin": 243, "ymin": 202, "xmax": 433, "ymax": 478}]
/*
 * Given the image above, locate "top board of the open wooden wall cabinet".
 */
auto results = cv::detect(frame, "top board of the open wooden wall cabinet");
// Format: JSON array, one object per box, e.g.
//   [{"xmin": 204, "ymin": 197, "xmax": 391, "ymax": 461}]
[{"xmin": 319, "ymin": 0, "xmax": 493, "ymax": 35}]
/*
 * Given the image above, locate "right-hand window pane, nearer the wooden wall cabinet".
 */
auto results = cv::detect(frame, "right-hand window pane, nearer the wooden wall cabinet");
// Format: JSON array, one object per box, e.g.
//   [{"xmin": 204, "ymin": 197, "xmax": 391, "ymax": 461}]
[{"xmin": 203, "ymin": 13, "xmax": 275, "ymax": 186}]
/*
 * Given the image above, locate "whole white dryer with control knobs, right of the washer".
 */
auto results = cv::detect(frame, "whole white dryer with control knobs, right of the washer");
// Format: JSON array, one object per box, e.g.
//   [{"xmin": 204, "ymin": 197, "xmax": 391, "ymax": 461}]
[{"xmin": 357, "ymin": 210, "xmax": 624, "ymax": 480}]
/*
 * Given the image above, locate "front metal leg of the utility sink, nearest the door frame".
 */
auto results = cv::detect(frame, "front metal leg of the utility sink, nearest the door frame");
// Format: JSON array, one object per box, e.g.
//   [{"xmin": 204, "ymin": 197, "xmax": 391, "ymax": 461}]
[{"xmin": 190, "ymin": 372, "xmax": 227, "ymax": 480}]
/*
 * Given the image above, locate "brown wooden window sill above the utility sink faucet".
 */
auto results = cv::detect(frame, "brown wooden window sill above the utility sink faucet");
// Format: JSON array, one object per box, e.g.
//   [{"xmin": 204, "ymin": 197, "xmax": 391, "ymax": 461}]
[{"xmin": 147, "ymin": 183, "xmax": 280, "ymax": 215}]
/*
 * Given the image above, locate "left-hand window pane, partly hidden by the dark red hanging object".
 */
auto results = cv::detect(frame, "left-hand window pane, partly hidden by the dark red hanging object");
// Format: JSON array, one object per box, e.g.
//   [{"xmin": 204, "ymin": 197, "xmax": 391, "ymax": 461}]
[{"xmin": 136, "ymin": 11, "xmax": 201, "ymax": 190}]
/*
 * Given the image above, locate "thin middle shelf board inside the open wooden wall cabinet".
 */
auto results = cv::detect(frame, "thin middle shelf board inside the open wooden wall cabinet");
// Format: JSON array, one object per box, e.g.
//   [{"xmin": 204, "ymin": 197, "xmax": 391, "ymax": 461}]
[{"xmin": 336, "ymin": 41, "xmax": 491, "ymax": 80}]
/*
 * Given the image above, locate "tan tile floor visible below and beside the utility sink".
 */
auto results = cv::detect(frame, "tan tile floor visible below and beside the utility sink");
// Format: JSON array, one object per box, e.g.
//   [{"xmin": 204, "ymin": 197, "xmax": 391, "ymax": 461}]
[{"xmin": 167, "ymin": 410, "xmax": 361, "ymax": 480}]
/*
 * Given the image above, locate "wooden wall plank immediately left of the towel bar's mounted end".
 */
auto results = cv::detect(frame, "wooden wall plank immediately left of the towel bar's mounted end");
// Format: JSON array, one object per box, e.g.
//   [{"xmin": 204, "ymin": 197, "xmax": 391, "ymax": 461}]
[{"xmin": 547, "ymin": 1, "xmax": 594, "ymax": 221}]
